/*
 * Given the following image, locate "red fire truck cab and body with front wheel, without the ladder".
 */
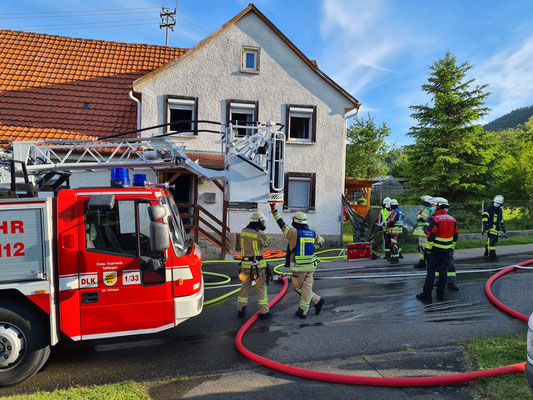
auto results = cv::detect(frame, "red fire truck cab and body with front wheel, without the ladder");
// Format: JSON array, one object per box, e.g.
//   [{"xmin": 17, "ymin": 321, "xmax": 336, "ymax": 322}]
[{"xmin": 0, "ymin": 183, "xmax": 204, "ymax": 386}]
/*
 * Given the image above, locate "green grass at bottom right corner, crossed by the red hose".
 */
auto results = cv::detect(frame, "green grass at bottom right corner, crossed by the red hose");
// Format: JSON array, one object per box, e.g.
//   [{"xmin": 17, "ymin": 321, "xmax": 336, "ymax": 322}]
[{"xmin": 465, "ymin": 332, "xmax": 533, "ymax": 400}]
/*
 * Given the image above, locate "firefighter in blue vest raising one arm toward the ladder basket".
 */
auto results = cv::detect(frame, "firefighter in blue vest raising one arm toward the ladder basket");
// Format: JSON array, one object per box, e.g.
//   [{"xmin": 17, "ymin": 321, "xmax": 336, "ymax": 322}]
[{"xmin": 270, "ymin": 204, "xmax": 325, "ymax": 319}]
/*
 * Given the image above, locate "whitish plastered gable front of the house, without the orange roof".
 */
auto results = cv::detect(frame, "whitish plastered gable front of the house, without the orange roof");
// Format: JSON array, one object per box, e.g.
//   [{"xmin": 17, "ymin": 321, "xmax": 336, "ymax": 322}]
[{"xmin": 132, "ymin": 6, "xmax": 358, "ymax": 244}]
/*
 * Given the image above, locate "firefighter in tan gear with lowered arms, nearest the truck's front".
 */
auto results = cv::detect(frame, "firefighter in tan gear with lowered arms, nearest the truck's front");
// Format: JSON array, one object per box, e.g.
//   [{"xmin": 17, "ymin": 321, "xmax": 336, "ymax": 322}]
[{"xmin": 237, "ymin": 212, "xmax": 271, "ymax": 319}]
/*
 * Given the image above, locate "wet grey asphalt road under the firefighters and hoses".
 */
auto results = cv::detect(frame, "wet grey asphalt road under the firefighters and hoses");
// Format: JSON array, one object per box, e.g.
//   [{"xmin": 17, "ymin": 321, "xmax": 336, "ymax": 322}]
[{"xmin": 0, "ymin": 245, "xmax": 533, "ymax": 400}]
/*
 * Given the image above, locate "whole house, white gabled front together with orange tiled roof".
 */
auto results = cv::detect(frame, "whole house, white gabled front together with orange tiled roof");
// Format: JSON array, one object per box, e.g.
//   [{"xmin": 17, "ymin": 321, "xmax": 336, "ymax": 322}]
[{"xmin": 0, "ymin": 5, "xmax": 359, "ymax": 252}]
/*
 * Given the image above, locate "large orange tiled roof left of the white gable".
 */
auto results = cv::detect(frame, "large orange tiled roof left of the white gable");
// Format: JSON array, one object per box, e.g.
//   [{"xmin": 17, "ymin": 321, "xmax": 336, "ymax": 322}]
[{"xmin": 0, "ymin": 30, "xmax": 187, "ymax": 142}]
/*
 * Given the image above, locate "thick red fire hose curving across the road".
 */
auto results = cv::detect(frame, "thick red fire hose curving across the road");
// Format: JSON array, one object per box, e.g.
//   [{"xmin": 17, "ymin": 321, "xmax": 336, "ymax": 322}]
[{"xmin": 235, "ymin": 260, "xmax": 533, "ymax": 387}]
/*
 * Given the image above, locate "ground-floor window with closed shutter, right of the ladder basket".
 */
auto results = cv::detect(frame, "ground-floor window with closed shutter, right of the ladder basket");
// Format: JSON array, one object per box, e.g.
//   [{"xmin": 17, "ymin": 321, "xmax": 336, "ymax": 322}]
[{"xmin": 283, "ymin": 172, "xmax": 316, "ymax": 211}]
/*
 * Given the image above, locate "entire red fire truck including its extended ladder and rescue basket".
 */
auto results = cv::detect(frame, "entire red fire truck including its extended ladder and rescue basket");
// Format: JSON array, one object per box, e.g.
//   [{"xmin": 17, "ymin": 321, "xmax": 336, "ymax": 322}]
[{"xmin": 0, "ymin": 121, "xmax": 285, "ymax": 386}]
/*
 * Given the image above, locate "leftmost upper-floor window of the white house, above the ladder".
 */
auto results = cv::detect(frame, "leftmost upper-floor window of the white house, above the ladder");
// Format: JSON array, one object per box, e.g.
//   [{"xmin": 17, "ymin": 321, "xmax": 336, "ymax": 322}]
[{"xmin": 165, "ymin": 96, "xmax": 198, "ymax": 135}]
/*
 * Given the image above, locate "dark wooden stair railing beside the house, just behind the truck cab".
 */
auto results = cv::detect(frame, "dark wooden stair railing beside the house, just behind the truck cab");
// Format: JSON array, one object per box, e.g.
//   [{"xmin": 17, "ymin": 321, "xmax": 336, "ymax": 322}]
[{"xmin": 176, "ymin": 201, "xmax": 231, "ymax": 258}]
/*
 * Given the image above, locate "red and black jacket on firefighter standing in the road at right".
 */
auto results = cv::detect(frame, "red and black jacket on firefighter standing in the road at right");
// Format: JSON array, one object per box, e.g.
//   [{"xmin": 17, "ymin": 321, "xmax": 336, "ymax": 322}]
[{"xmin": 426, "ymin": 209, "xmax": 459, "ymax": 253}]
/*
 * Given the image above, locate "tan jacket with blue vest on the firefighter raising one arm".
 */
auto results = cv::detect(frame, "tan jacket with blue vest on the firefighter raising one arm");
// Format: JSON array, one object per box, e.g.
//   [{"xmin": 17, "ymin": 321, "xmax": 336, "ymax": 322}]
[{"xmin": 272, "ymin": 210, "xmax": 325, "ymax": 271}]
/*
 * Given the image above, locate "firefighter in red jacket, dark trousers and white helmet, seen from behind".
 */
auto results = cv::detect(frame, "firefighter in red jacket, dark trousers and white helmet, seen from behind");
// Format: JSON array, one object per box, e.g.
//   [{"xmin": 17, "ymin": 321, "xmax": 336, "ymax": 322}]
[{"xmin": 416, "ymin": 197, "xmax": 459, "ymax": 301}]
